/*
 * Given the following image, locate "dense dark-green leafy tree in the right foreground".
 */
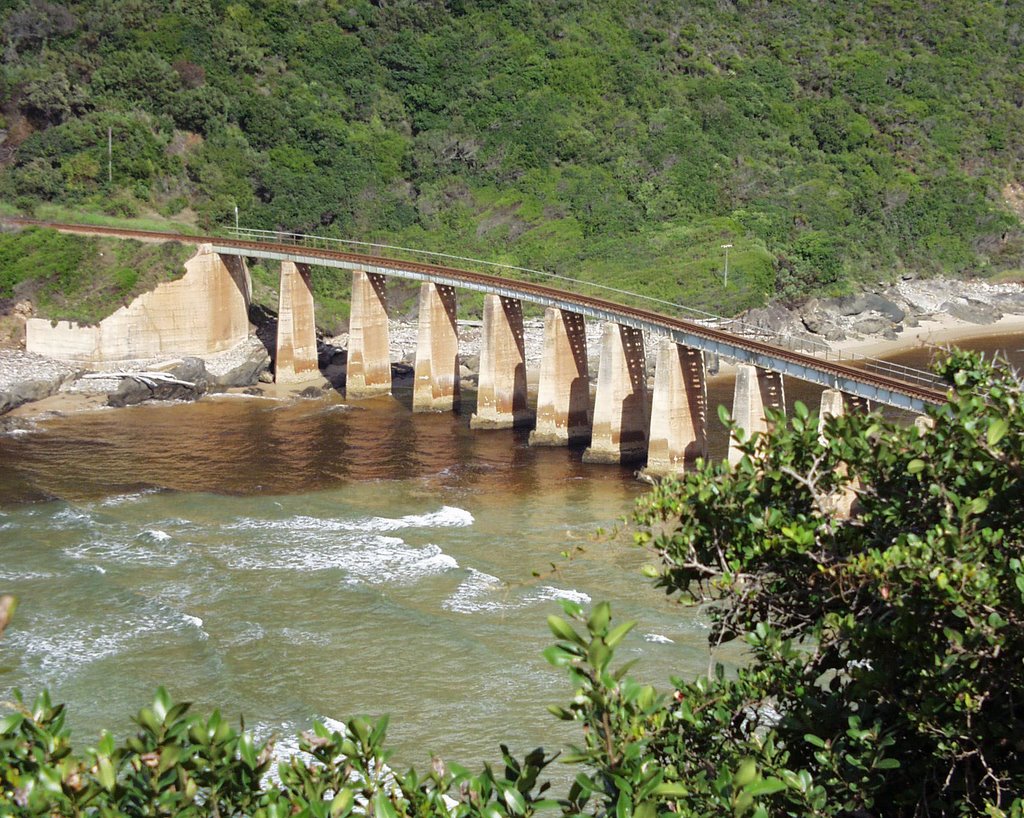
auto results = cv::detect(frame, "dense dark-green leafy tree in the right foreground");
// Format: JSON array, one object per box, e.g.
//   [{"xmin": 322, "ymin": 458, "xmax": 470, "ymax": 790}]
[{"xmin": 637, "ymin": 353, "xmax": 1024, "ymax": 816}]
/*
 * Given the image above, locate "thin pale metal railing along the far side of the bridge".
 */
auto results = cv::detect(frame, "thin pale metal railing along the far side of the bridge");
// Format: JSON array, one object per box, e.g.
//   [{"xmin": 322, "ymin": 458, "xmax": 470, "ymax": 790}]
[{"xmin": 224, "ymin": 225, "xmax": 945, "ymax": 389}]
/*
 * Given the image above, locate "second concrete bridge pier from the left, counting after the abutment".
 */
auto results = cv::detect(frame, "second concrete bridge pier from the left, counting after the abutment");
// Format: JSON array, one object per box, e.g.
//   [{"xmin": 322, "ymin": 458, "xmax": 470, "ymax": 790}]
[{"xmin": 345, "ymin": 270, "xmax": 391, "ymax": 398}]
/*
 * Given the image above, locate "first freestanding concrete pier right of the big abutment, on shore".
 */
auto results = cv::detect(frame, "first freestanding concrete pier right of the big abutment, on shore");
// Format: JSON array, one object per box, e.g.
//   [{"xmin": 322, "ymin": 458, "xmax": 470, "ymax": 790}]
[{"xmin": 273, "ymin": 261, "xmax": 319, "ymax": 383}]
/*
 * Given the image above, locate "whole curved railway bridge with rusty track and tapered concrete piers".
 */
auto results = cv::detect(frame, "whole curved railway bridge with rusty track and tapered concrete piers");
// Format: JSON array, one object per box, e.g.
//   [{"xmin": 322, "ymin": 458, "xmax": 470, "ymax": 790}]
[{"xmin": 8, "ymin": 219, "xmax": 945, "ymax": 475}]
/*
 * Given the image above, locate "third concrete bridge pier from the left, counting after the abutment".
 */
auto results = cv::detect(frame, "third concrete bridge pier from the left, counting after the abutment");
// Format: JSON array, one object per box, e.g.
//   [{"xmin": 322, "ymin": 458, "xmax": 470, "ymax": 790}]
[{"xmin": 413, "ymin": 282, "xmax": 459, "ymax": 412}]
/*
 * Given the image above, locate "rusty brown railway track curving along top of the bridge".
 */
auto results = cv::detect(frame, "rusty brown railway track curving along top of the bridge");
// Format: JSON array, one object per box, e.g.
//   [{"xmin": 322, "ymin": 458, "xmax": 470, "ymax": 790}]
[{"xmin": 2, "ymin": 217, "xmax": 946, "ymax": 405}]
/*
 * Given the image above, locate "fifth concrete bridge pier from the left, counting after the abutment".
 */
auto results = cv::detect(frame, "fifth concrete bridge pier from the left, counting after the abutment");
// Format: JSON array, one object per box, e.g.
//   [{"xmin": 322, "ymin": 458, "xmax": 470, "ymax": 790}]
[{"xmin": 529, "ymin": 307, "xmax": 590, "ymax": 446}]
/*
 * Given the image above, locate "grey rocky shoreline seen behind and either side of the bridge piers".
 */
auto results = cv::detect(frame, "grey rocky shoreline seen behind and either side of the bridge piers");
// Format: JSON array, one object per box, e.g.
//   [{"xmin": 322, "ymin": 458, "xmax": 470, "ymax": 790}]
[{"xmin": 0, "ymin": 279, "xmax": 1024, "ymax": 425}]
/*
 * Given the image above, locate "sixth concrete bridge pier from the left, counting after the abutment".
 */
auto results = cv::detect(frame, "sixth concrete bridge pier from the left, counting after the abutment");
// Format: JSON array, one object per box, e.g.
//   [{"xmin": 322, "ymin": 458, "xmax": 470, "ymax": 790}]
[{"xmin": 583, "ymin": 322, "xmax": 648, "ymax": 463}]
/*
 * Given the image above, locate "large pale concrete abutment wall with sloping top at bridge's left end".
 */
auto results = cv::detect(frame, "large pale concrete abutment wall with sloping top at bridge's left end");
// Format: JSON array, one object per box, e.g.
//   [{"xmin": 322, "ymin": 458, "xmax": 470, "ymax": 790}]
[{"xmin": 26, "ymin": 245, "xmax": 252, "ymax": 363}]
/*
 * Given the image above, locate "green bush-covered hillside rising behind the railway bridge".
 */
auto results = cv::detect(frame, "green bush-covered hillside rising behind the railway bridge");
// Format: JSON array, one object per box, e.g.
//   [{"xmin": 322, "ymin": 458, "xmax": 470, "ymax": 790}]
[{"xmin": 0, "ymin": 0, "xmax": 1024, "ymax": 311}]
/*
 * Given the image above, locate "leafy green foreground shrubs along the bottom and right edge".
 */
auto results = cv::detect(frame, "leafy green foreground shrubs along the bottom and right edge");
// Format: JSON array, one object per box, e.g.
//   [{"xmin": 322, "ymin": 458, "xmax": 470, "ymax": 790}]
[{"xmin": 0, "ymin": 354, "xmax": 1024, "ymax": 818}]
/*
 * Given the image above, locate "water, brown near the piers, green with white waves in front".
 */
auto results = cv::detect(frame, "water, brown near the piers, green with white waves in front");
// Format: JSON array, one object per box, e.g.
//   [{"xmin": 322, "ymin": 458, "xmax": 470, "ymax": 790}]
[{"xmin": 0, "ymin": 337, "xmax": 1024, "ymax": 767}]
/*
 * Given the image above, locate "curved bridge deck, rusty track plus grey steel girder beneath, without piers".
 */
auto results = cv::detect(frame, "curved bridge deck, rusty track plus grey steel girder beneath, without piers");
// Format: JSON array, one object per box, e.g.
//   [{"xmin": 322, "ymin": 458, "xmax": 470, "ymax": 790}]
[{"xmin": 0, "ymin": 217, "xmax": 946, "ymax": 412}]
